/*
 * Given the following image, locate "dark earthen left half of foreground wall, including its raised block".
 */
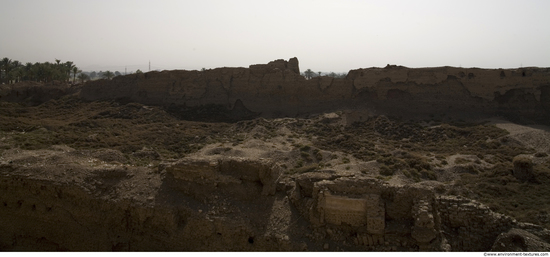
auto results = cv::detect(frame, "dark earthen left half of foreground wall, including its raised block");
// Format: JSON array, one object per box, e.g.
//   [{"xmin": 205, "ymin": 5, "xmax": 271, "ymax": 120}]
[{"xmin": 0, "ymin": 156, "xmax": 288, "ymax": 251}]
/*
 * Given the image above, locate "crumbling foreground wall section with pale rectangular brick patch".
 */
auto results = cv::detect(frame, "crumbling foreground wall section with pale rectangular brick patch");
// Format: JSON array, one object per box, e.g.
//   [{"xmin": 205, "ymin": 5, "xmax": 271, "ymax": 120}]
[{"xmin": 291, "ymin": 174, "xmax": 548, "ymax": 251}]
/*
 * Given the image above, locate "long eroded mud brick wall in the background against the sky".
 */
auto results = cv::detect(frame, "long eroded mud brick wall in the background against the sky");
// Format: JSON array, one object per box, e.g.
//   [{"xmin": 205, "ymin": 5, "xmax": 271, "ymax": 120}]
[{"xmin": 80, "ymin": 58, "xmax": 550, "ymax": 122}]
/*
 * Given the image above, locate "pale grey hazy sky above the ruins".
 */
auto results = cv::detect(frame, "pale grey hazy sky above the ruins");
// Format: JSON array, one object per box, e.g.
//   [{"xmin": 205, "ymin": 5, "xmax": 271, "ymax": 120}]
[{"xmin": 0, "ymin": 0, "xmax": 550, "ymax": 72}]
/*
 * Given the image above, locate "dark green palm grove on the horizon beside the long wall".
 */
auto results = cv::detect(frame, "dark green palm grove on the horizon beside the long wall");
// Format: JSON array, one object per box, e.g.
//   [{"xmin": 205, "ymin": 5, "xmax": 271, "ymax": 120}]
[{"xmin": 0, "ymin": 57, "xmax": 120, "ymax": 84}]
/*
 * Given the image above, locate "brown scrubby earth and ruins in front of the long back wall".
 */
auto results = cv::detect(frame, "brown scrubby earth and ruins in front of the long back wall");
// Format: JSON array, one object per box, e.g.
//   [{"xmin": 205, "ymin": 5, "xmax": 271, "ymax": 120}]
[{"xmin": 0, "ymin": 96, "xmax": 550, "ymax": 251}]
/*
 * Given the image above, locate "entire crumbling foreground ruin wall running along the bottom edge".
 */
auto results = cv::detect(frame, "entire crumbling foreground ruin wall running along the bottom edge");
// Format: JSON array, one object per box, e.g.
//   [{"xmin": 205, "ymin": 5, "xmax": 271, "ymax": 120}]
[{"xmin": 4, "ymin": 149, "xmax": 550, "ymax": 251}]
